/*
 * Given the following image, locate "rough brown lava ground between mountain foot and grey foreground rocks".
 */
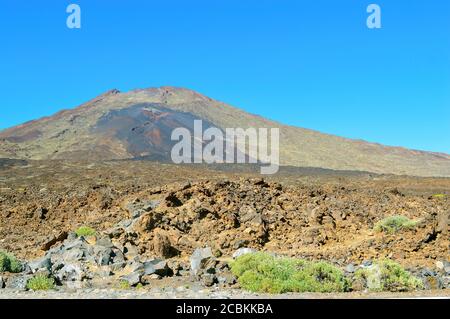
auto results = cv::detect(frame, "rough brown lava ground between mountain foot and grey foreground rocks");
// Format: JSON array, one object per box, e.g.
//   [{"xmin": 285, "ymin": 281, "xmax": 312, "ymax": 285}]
[{"xmin": 0, "ymin": 161, "xmax": 450, "ymax": 274}]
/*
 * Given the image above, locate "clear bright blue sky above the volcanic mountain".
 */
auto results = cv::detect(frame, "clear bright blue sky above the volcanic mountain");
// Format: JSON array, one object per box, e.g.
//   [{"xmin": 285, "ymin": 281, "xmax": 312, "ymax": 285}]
[{"xmin": 0, "ymin": 0, "xmax": 450, "ymax": 153}]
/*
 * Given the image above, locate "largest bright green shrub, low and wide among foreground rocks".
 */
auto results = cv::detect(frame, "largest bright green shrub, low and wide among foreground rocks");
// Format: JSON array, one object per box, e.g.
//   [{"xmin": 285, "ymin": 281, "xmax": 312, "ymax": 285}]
[{"xmin": 231, "ymin": 253, "xmax": 348, "ymax": 293}]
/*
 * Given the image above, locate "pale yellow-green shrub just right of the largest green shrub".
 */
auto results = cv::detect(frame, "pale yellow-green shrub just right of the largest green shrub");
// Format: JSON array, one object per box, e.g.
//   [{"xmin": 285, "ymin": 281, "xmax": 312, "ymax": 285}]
[{"xmin": 355, "ymin": 259, "xmax": 424, "ymax": 291}]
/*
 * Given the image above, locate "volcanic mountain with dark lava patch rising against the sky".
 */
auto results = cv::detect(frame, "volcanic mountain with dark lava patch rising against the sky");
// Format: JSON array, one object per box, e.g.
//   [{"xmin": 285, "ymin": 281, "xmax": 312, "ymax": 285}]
[{"xmin": 0, "ymin": 87, "xmax": 450, "ymax": 176}]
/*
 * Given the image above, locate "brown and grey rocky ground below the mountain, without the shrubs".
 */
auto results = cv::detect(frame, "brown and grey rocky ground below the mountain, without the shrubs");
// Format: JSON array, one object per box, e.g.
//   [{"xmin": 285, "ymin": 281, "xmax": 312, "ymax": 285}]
[{"xmin": 0, "ymin": 161, "xmax": 450, "ymax": 298}]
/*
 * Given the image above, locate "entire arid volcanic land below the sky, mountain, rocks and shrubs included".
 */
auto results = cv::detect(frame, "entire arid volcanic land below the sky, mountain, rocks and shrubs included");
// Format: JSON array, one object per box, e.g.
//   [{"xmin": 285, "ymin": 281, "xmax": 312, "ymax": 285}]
[{"xmin": 0, "ymin": 87, "xmax": 450, "ymax": 298}]
